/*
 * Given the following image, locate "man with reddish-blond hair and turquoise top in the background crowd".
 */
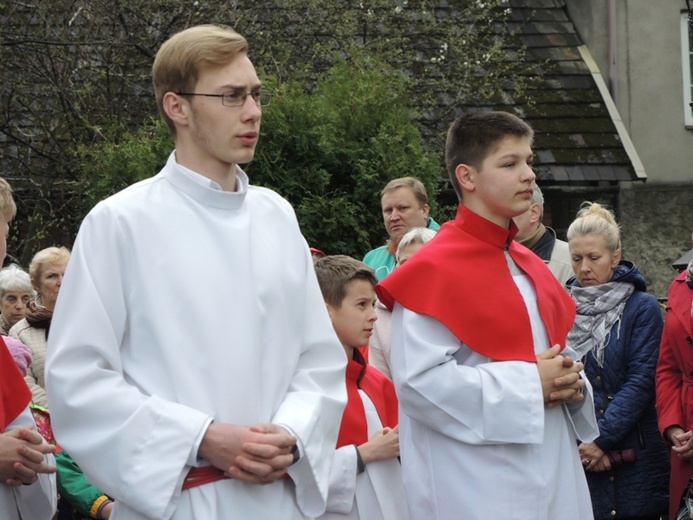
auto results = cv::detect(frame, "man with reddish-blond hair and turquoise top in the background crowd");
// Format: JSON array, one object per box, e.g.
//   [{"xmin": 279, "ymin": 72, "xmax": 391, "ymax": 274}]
[{"xmin": 363, "ymin": 177, "xmax": 440, "ymax": 280}]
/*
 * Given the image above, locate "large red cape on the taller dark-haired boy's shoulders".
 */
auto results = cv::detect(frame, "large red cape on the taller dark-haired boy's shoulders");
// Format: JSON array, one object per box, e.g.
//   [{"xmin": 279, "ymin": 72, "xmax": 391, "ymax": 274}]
[{"xmin": 376, "ymin": 204, "xmax": 575, "ymax": 362}]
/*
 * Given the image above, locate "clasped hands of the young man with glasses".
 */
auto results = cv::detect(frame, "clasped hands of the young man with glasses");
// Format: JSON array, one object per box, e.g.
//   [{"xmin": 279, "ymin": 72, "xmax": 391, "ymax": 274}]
[{"xmin": 198, "ymin": 423, "xmax": 296, "ymax": 484}]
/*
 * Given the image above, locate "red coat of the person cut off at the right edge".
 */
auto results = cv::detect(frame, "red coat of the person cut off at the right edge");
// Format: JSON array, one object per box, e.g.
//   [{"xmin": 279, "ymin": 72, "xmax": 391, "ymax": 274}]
[{"xmin": 655, "ymin": 271, "xmax": 693, "ymax": 518}]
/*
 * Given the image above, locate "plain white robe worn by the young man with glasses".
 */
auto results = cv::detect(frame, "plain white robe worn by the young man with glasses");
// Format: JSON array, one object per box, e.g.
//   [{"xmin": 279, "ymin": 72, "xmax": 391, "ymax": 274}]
[{"xmin": 46, "ymin": 154, "xmax": 346, "ymax": 520}]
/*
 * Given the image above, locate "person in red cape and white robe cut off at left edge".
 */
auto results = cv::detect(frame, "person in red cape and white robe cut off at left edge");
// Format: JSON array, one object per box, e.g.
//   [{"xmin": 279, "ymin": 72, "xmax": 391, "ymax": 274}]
[{"xmin": 0, "ymin": 178, "xmax": 58, "ymax": 520}]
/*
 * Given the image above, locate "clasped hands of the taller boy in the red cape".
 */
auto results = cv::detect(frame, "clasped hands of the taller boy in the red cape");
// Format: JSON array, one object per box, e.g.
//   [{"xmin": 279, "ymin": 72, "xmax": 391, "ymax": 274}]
[{"xmin": 537, "ymin": 345, "xmax": 585, "ymax": 408}]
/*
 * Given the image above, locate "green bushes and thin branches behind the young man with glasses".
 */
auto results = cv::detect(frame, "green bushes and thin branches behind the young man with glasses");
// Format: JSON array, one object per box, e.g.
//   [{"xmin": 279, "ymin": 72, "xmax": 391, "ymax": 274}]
[{"xmin": 0, "ymin": 0, "xmax": 536, "ymax": 262}]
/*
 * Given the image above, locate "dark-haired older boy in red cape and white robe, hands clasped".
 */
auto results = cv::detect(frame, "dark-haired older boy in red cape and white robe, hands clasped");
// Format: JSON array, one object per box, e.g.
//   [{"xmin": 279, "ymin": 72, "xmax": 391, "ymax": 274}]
[{"xmin": 376, "ymin": 112, "xmax": 598, "ymax": 520}]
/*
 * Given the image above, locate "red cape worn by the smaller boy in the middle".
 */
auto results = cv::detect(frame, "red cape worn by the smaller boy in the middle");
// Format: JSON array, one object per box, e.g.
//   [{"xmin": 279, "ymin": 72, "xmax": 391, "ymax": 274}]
[{"xmin": 337, "ymin": 349, "xmax": 397, "ymax": 448}]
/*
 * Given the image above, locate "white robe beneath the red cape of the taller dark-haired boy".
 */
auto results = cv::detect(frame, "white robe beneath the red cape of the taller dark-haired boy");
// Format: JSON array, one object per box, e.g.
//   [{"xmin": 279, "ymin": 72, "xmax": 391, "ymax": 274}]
[{"xmin": 392, "ymin": 262, "xmax": 598, "ymax": 520}]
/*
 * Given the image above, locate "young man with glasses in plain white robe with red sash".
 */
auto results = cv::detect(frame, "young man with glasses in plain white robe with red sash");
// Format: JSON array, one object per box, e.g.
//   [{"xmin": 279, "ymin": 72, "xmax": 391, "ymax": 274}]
[{"xmin": 47, "ymin": 25, "xmax": 346, "ymax": 519}]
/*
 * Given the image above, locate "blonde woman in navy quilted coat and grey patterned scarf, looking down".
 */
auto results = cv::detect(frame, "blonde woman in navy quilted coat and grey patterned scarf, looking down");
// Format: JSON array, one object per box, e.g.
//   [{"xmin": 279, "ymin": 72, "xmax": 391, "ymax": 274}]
[{"xmin": 567, "ymin": 203, "xmax": 669, "ymax": 520}]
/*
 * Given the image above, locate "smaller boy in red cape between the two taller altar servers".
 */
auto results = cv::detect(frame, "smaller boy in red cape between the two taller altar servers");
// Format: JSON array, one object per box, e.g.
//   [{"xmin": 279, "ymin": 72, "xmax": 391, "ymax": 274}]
[{"xmin": 315, "ymin": 255, "xmax": 409, "ymax": 520}]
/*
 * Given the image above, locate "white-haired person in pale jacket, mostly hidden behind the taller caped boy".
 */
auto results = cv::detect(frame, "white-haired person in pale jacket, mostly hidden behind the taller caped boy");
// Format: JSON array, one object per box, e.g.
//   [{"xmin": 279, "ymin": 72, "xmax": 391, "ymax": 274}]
[{"xmin": 368, "ymin": 227, "xmax": 436, "ymax": 379}]
